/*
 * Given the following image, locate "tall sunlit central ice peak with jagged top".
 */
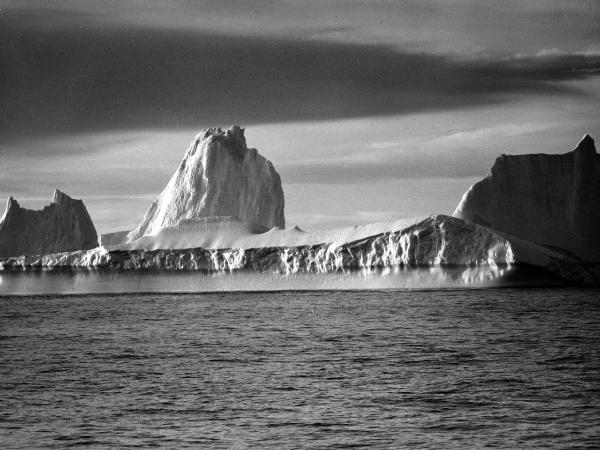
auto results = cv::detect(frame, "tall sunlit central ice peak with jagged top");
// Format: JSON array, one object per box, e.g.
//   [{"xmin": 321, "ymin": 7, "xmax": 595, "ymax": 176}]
[{"xmin": 126, "ymin": 126, "xmax": 285, "ymax": 242}]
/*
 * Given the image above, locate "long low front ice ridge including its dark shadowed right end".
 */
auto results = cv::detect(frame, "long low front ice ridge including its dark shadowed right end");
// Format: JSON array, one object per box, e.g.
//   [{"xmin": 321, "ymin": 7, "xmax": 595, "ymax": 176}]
[{"xmin": 0, "ymin": 215, "xmax": 600, "ymax": 285}]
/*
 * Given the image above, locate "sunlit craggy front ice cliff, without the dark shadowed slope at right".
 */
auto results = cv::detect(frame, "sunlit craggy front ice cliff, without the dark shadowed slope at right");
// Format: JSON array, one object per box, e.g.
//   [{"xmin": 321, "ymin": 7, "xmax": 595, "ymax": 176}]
[{"xmin": 2, "ymin": 215, "xmax": 514, "ymax": 274}]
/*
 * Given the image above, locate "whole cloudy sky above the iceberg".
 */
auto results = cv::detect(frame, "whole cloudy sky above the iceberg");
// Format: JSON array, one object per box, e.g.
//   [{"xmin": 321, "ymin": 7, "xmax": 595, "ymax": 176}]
[{"xmin": 0, "ymin": 0, "xmax": 600, "ymax": 233}]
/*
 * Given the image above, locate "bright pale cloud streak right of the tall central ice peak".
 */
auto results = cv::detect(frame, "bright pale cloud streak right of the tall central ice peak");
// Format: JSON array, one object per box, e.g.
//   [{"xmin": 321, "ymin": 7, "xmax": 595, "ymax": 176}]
[{"xmin": 266, "ymin": 112, "xmax": 598, "ymax": 185}]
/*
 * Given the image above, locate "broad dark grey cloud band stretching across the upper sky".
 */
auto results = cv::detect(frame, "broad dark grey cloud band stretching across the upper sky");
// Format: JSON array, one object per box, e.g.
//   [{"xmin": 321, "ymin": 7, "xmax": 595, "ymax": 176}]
[{"xmin": 0, "ymin": 9, "xmax": 600, "ymax": 140}]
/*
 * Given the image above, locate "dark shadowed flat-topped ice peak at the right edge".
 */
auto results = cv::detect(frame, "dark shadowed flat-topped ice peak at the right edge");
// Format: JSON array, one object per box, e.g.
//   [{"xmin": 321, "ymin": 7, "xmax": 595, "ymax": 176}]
[{"xmin": 454, "ymin": 135, "xmax": 600, "ymax": 261}]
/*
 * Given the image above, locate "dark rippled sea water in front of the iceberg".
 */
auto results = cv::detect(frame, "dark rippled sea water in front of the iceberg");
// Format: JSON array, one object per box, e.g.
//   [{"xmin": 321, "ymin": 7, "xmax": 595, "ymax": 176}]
[{"xmin": 0, "ymin": 288, "xmax": 600, "ymax": 448}]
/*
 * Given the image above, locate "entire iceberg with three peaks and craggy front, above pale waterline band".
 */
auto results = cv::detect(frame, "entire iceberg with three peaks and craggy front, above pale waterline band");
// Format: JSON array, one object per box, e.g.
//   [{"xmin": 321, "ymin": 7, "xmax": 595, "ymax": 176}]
[{"xmin": 0, "ymin": 126, "xmax": 600, "ymax": 286}]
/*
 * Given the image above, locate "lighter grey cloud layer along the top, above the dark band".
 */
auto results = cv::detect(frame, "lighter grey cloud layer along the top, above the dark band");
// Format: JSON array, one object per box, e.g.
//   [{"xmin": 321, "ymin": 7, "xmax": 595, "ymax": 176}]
[{"xmin": 3, "ymin": 0, "xmax": 600, "ymax": 55}]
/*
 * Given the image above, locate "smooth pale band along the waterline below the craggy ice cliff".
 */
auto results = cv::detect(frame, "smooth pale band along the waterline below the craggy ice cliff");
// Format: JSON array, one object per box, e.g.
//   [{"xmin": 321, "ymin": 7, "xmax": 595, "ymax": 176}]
[{"xmin": 0, "ymin": 265, "xmax": 560, "ymax": 295}]
